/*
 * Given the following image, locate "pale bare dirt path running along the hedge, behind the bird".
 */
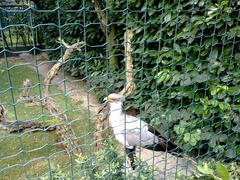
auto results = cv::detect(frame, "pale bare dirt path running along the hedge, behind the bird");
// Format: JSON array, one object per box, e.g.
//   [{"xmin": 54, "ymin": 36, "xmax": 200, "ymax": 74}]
[{"xmin": 0, "ymin": 53, "xmax": 195, "ymax": 179}]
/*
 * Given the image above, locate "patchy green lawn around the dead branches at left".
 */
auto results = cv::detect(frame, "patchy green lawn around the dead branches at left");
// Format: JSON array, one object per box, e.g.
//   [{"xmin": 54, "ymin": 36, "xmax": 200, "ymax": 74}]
[{"xmin": 0, "ymin": 63, "xmax": 93, "ymax": 179}]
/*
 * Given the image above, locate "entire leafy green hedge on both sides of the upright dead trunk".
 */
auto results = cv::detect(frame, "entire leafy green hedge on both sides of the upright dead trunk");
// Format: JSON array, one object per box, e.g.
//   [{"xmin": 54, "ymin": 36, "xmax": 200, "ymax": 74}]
[{"xmin": 34, "ymin": 0, "xmax": 240, "ymax": 161}]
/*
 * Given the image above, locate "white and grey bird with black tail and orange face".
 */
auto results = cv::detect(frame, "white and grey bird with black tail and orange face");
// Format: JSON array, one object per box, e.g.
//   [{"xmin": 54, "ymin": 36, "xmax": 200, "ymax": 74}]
[{"xmin": 104, "ymin": 93, "xmax": 183, "ymax": 169}]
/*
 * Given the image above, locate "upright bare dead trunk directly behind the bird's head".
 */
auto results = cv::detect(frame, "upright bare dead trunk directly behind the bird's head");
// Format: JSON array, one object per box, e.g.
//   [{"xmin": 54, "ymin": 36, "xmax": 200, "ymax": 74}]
[{"xmin": 94, "ymin": 30, "xmax": 136, "ymax": 149}]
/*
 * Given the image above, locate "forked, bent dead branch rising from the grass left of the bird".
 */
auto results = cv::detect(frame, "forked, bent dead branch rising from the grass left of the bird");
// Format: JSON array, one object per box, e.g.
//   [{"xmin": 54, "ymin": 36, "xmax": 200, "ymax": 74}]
[{"xmin": 44, "ymin": 39, "xmax": 84, "ymax": 154}]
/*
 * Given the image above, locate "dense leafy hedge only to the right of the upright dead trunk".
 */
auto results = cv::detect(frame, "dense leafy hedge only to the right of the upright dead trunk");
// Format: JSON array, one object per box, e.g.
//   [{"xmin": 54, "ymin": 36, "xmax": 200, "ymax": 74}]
[{"xmin": 122, "ymin": 0, "xmax": 240, "ymax": 161}]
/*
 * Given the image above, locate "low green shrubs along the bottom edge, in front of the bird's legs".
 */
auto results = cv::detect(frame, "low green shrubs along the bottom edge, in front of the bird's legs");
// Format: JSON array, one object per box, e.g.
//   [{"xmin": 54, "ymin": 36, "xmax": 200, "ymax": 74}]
[{"xmin": 43, "ymin": 140, "xmax": 156, "ymax": 180}]
